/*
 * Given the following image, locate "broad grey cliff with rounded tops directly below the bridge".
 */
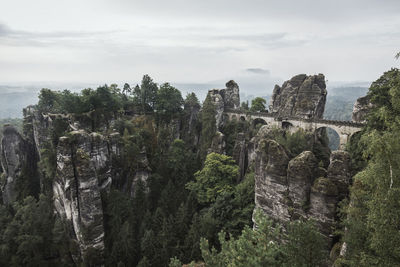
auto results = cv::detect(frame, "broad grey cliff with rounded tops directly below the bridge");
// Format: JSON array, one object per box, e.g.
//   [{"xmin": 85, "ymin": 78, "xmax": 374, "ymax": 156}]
[{"xmin": 255, "ymin": 139, "xmax": 350, "ymax": 241}]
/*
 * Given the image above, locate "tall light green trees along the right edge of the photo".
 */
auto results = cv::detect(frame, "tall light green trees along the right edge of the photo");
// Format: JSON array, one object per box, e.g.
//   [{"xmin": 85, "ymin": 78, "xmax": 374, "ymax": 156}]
[{"xmin": 340, "ymin": 69, "xmax": 400, "ymax": 266}]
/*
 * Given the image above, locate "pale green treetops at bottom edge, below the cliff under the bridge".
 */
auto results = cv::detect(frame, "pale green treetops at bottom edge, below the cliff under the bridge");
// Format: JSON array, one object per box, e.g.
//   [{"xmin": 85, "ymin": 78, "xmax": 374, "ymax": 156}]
[{"xmin": 169, "ymin": 210, "xmax": 326, "ymax": 267}]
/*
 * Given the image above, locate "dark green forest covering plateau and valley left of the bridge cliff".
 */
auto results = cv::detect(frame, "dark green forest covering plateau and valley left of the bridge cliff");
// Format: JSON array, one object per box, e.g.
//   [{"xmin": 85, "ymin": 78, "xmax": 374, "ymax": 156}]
[{"xmin": 0, "ymin": 75, "xmax": 254, "ymax": 266}]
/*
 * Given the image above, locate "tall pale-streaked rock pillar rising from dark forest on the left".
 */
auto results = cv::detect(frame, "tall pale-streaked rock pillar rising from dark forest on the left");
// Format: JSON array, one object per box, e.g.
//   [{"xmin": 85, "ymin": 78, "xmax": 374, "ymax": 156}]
[{"xmin": 53, "ymin": 130, "xmax": 111, "ymax": 259}]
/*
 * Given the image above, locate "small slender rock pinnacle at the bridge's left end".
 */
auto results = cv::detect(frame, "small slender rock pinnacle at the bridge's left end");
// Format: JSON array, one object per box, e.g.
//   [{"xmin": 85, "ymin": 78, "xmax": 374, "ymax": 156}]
[{"xmin": 208, "ymin": 80, "xmax": 240, "ymax": 129}]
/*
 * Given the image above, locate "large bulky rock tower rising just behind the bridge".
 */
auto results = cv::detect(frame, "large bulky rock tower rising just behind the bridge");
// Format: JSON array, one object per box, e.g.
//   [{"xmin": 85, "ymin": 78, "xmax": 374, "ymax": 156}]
[{"xmin": 269, "ymin": 74, "xmax": 327, "ymax": 119}]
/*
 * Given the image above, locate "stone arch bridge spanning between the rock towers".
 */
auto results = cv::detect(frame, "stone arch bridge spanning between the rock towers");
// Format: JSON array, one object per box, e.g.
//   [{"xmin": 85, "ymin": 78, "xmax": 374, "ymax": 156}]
[{"xmin": 223, "ymin": 109, "xmax": 364, "ymax": 149}]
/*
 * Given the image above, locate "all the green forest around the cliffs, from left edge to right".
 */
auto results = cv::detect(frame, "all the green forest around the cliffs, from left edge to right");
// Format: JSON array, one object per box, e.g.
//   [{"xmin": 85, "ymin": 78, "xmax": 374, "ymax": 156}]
[{"xmin": 0, "ymin": 69, "xmax": 400, "ymax": 267}]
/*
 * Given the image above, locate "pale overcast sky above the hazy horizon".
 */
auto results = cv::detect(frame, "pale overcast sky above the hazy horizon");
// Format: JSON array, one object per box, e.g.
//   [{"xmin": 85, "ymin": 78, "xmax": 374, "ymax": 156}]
[{"xmin": 0, "ymin": 0, "xmax": 400, "ymax": 94}]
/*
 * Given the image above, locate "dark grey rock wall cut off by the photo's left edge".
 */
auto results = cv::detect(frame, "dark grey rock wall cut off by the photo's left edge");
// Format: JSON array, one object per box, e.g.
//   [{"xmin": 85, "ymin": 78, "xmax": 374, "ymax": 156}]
[{"xmin": 0, "ymin": 125, "xmax": 39, "ymax": 204}]
